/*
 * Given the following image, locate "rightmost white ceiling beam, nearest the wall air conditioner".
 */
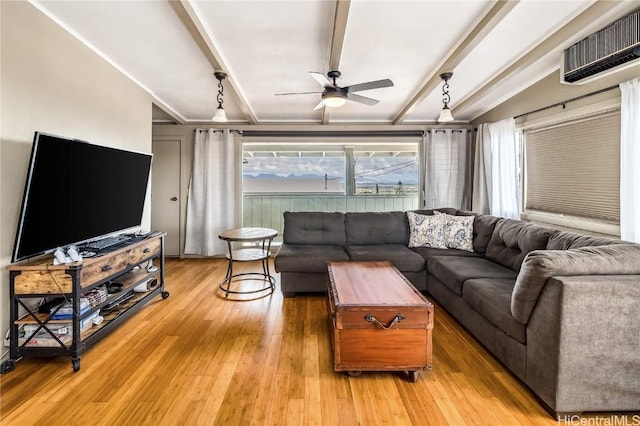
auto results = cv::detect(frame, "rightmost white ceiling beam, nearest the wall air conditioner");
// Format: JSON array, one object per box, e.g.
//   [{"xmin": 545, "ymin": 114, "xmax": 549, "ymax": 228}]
[{"xmin": 451, "ymin": 1, "xmax": 621, "ymax": 119}]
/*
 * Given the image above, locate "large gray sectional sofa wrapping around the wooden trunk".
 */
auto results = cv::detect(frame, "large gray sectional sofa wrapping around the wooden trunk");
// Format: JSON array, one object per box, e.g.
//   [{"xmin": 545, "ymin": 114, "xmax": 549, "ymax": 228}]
[{"xmin": 275, "ymin": 209, "xmax": 640, "ymax": 416}]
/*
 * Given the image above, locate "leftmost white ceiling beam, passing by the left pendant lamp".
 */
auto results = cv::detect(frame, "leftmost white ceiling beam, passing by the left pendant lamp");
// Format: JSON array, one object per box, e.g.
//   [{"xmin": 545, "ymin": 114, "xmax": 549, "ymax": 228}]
[{"xmin": 172, "ymin": 0, "xmax": 258, "ymax": 124}]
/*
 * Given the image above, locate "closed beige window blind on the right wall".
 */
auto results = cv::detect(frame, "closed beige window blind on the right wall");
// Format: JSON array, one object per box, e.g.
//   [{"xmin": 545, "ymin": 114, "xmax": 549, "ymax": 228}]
[{"xmin": 525, "ymin": 110, "xmax": 620, "ymax": 223}]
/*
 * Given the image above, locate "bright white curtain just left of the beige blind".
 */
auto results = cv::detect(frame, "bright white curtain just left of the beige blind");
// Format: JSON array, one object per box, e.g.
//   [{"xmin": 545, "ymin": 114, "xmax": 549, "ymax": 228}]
[{"xmin": 472, "ymin": 118, "xmax": 522, "ymax": 219}]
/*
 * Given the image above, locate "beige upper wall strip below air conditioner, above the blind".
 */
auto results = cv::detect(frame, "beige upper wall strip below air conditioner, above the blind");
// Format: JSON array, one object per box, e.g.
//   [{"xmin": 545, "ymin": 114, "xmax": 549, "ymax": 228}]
[{"xmin": 473, "ymin": 64, "xmax": 640, "ymax": 125}]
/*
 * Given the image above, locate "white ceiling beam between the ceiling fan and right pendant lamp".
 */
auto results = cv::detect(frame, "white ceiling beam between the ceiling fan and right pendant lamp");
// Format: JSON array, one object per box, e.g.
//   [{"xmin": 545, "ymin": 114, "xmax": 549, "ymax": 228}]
[{"xmin": 393, "ymin": 0, "xmax": 520, "ymax": 124}]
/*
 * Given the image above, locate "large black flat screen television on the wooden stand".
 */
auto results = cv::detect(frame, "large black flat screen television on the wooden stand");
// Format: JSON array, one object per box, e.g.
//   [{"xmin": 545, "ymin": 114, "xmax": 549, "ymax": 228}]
[{"xmin": 13, "ymin": 132, "xmax": 152, "ymax": 262}]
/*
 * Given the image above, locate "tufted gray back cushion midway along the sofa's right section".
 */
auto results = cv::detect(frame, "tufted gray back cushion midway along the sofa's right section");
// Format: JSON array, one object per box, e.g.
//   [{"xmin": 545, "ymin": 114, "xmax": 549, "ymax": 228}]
[{"xmin": 486, "ymin": 219, "xmax": 557, "ymax": 272}]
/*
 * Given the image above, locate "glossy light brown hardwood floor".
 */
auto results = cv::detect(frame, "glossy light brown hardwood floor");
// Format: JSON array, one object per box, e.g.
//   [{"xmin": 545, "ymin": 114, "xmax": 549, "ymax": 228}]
[{"xmin": 0, "ymin": 259, "xmax": 640, "ymax": 425}]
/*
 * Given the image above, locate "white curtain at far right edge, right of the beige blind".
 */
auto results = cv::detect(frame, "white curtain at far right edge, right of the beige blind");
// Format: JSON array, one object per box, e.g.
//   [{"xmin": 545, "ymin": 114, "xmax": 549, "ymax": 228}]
[{"xmin": 620, "ymin": 78, "xmax": 640, "ymax": 243}]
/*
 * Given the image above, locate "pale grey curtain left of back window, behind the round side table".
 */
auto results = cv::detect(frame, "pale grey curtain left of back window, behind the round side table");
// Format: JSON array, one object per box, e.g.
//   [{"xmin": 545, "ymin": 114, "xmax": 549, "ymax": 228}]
[{"xmin": 184, "ymin": 129, "xmax": 241, "ymax": 256}]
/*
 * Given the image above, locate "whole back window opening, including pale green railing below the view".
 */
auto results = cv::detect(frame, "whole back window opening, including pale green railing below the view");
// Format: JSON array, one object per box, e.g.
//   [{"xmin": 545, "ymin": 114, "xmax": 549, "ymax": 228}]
[{"xmin": 242, "ymin": 142, "xmax": 419, "ymax": 236}]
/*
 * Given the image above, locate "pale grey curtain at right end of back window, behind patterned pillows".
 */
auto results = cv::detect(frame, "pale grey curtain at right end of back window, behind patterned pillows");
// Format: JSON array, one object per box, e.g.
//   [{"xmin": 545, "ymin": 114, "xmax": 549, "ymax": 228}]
[{"xmin": 422, "ymin": 130, "xmax": 470, "ymax": 209}]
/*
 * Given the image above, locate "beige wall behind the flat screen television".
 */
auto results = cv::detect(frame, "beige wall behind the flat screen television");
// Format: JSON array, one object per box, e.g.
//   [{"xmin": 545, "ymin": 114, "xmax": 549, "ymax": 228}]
[{"xmin": 0, "ymin": 1, "xmax": 152, "ymax": 354}]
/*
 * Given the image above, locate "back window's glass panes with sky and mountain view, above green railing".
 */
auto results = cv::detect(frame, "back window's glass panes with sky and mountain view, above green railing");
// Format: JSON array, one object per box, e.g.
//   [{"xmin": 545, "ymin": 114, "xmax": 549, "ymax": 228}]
[{"xmin": 242, "ymin": 143, "xmax": 419, "ymax": 198}]
